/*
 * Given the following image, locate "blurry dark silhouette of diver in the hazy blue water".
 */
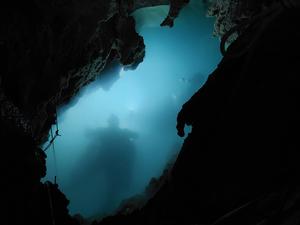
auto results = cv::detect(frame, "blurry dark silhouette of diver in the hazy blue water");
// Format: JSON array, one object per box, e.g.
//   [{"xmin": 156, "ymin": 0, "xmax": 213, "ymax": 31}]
[{"xmin": 71, "ymin": 115, "xmax": 138, "ymax": 212}]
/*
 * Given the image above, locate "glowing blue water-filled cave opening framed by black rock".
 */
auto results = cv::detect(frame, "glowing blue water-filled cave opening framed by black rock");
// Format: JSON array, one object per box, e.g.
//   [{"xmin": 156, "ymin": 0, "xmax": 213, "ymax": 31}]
[{"xmin": 41, "ymin": 0, "xmax": 221, "ymax": 220}]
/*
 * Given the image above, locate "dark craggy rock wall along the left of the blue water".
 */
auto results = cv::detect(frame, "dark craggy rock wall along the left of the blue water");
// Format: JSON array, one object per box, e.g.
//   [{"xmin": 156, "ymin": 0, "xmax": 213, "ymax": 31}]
[{"xmin": 0, "ymin": 0, "xmax": 182, "ymax": 225}]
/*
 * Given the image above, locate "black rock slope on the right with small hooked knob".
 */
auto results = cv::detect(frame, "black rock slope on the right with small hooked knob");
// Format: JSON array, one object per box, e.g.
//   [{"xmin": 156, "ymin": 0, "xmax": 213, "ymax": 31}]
[{"xmin": 98, "ymin": 3, "xmax": 300, "ymax": 225}]
